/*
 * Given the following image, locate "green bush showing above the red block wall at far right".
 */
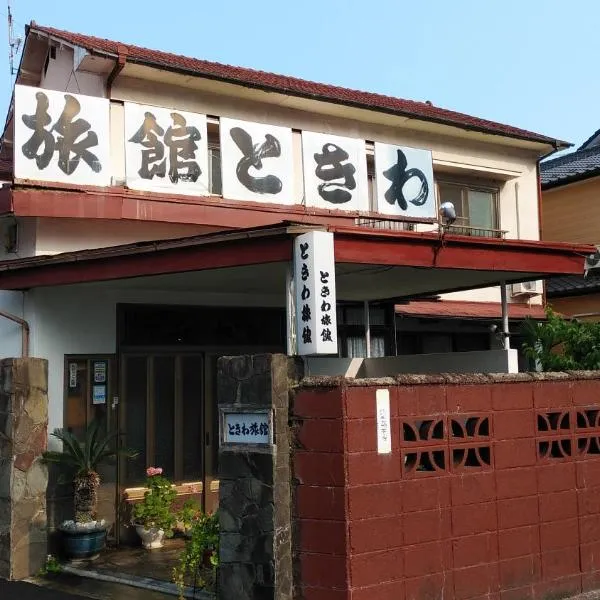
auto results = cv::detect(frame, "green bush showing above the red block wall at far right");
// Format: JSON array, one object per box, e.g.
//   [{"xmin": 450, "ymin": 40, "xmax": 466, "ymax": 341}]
[{"xmin": 522, "ymin": 308, "xmax": 600, "ymax": 371}]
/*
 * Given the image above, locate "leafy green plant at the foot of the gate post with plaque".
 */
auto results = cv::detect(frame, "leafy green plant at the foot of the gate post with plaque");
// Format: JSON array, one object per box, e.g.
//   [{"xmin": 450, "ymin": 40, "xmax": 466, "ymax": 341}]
[{"xmin": 173, "ymin": 512, "xmax": 220, "ymax": 600}]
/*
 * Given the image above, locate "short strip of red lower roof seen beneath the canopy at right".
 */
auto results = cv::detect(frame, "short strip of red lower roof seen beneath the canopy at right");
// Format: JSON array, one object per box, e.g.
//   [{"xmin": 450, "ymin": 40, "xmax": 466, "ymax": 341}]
[{"xmin": 396, "ymin": 300, "xmax": 546, "ymax": 319}]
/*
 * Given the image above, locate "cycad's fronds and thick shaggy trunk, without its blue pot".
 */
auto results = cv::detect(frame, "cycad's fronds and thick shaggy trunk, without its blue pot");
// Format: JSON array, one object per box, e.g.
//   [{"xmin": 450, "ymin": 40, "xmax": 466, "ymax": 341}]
[{"xmin": 43, "ymin": 420, "xmax": 137, "ymax": 523}]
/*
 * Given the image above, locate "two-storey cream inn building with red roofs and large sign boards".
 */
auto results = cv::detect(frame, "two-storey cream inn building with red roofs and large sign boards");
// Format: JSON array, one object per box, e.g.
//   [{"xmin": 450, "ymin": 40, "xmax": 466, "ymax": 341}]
[{"xmin": 0, "ymin": 24, "xmax": 591, "ymax": 536}]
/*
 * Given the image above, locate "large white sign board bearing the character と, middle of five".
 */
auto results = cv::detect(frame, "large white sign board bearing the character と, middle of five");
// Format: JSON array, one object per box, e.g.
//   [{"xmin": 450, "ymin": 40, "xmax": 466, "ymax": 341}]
[{"xmin": 220, "ymin": 118, "xmax": 294, "ymax": 204}]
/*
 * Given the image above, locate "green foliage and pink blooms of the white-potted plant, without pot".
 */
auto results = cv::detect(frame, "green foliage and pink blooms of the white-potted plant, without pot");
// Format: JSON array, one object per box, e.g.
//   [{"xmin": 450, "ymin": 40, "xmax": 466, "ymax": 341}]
[{"xmin": 133, "ymin": 467, "xmax": 177, "ymax": 537}]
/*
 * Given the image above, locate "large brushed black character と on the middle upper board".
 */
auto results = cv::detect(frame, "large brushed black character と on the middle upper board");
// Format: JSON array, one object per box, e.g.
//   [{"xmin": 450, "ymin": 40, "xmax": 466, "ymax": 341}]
[{"xmin": 229, "ymin": 127, "xmax": 283, "ymax": 194}]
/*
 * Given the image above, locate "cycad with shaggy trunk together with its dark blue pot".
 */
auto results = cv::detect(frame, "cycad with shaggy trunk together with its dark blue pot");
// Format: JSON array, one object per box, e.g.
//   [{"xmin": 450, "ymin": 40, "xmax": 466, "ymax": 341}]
[{"xmin": 43, "ymin": 421, "xmax": 136, "ymax": 558}]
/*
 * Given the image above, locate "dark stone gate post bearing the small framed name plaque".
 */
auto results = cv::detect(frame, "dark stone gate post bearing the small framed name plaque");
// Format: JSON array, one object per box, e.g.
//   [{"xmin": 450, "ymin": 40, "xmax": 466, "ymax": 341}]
[{"xmin": 217, "ymin": 354, "xmax": 299, "ymax": 600}]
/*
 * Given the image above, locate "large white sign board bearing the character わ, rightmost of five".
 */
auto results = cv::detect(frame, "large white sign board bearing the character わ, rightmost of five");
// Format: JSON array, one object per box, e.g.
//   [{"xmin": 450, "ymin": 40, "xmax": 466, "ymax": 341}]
[{"xmin": 375, "ymin": 142, "xmax": 436, "ymax": 219}]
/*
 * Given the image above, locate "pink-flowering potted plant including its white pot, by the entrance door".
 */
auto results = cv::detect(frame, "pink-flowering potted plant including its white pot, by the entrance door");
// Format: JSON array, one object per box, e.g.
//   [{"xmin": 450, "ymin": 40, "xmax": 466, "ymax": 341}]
[{"xmin": 133, "ymin": 467, "xmax": 177, "ymax": 550}]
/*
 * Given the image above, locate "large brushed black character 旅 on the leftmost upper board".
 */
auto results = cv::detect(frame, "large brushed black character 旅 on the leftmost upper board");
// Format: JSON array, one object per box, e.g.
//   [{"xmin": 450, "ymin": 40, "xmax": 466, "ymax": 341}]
[{"xmin": 21, "ymin": 92, "xmax": 102, "ymax": 175}]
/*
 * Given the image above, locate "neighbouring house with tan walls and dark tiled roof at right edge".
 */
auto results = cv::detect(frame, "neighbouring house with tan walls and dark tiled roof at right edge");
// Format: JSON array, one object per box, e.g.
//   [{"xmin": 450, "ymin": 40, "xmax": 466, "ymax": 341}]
[{"xmin": 540, "ymin": 130, "xmax": 600, "ymax": 320}]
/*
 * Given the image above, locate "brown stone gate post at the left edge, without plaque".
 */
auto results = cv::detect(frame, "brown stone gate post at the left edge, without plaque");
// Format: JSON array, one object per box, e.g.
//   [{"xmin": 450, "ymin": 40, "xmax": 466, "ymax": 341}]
[{"xmin": 0, "ymin": 358, "xmax": 48, "ymax": 579}]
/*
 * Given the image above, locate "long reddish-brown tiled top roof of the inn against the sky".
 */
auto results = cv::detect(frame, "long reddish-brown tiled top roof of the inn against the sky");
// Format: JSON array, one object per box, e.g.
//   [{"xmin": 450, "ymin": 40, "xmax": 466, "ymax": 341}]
[{"xmin": 29, "ymin": 22, "xmax": 567, "ymax": 147}]
